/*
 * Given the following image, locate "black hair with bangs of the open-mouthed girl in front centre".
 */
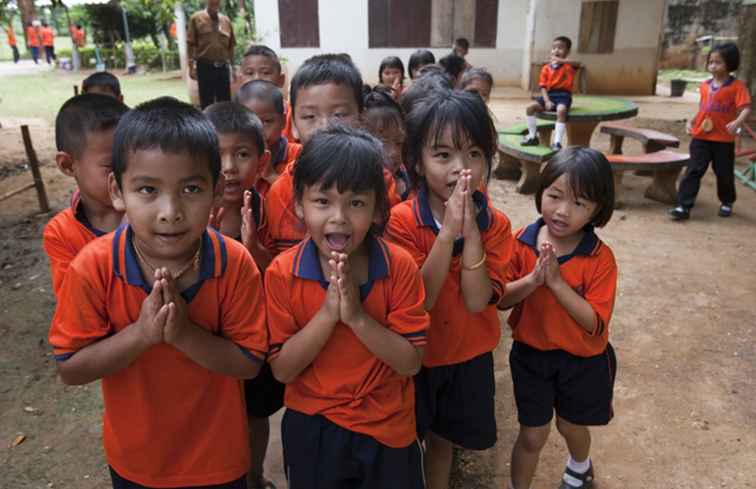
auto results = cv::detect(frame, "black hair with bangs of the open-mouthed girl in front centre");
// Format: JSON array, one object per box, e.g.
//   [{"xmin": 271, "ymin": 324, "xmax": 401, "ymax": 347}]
[{"xmin": 294, "ymin": 124, "xmax": 389, "ymax": 227}]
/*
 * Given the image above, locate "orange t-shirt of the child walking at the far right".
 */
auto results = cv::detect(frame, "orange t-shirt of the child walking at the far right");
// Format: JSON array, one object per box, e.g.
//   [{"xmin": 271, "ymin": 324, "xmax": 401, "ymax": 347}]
[{"xmin": 692, "ymin": 77, "xmax": 751, "ymax": 143}]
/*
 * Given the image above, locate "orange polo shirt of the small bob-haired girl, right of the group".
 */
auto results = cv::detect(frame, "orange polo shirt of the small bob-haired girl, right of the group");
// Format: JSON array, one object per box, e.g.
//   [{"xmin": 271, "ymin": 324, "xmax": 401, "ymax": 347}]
[{"xmin": 507, "ymin": 219, "xmax": 617, "ymax": 357}]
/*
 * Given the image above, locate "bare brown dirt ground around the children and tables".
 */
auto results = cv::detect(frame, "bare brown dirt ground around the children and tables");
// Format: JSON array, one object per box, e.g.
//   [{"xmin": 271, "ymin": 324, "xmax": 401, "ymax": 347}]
[{"xmin": 0, "ymin": 85, "xmax": 756, "ymax": 489}]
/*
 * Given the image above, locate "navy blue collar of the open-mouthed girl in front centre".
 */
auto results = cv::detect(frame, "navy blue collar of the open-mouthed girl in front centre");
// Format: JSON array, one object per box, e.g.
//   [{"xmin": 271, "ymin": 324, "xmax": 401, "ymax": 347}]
[{"xmin": 293, "ymin": 234, "xmax": 389, "ymax": 301}]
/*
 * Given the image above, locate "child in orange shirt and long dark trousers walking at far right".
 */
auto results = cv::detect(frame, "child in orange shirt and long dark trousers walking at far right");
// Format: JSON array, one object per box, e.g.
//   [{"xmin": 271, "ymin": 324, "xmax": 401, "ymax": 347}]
[{"xmin": 670, "ymin": 43, "xmax": 751, "ymax": 221}]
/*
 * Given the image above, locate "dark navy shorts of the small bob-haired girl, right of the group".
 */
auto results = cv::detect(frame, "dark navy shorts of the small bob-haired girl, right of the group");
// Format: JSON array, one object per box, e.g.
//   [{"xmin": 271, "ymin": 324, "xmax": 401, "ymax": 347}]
[{"xmin": 509, "ymin": 341, "xmax": 617, "ymax": 427}]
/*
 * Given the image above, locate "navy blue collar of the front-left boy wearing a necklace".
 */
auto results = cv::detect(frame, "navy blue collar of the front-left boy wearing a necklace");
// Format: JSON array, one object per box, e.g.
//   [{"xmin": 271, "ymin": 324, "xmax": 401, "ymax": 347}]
[{"xmin": 113, "ymin": 224, "xmax": 228, "ymax": 303}]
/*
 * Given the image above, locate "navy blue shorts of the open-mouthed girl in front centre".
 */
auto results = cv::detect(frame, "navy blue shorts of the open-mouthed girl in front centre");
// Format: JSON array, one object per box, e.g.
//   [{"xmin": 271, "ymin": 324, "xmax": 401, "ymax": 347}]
[{"xmin": 281, "ymin": 409, "xmax": 425, "ymax": 489}]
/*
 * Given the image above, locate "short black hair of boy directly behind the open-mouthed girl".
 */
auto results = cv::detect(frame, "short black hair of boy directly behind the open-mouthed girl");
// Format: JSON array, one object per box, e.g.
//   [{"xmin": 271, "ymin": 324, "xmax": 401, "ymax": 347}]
[{"xmin": 289, "ymin": 53, "xmax": 362, "ymax": 115}]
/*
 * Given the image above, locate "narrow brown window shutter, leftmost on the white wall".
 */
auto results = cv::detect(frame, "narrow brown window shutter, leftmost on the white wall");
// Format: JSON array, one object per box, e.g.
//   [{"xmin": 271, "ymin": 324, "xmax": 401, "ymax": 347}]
[{"xmin": 278, "ymin": 0, "xmax": 320, "ymax": 48}]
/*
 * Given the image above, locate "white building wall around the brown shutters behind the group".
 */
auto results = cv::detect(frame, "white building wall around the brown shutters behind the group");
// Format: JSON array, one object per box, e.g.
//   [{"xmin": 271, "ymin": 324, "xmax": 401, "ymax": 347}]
[{"xmin": 255, "ymin": 0, "xmax": 529, "ymax": 85}]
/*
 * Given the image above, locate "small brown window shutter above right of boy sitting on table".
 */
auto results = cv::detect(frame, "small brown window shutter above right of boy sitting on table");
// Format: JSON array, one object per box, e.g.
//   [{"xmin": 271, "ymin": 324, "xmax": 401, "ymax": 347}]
[{"xmin": 578, "ymin": 0, "xmax": 619, "ymax": 54}]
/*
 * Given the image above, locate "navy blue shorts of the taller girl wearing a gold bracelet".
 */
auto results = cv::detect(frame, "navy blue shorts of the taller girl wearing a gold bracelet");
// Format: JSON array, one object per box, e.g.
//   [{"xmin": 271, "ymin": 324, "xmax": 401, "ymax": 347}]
[{"xmin": 415, "ymin": 352, "xmax": 496, "ymax": 450}]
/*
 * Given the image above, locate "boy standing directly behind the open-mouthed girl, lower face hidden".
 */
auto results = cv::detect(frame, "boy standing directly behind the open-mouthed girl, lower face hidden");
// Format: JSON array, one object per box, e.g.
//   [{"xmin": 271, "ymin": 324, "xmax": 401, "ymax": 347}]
[{"xmin": 265, "ymin": 54, "xmax": 400, "ymax": 253}]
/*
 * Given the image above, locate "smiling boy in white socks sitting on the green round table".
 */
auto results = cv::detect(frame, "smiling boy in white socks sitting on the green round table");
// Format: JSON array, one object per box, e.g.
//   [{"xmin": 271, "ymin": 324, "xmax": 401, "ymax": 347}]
[{"xmin": 522, "ymin": 36, "xmax": 575, "ymax": 151}]
